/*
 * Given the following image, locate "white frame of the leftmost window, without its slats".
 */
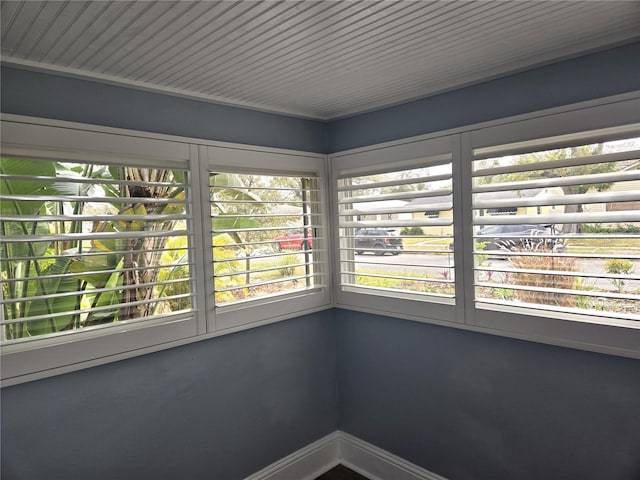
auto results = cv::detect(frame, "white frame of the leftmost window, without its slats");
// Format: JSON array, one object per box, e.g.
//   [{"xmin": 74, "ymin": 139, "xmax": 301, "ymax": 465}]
[{"xmin": 2, "ymin": 118, "xmax": 201, "ymax": 385}]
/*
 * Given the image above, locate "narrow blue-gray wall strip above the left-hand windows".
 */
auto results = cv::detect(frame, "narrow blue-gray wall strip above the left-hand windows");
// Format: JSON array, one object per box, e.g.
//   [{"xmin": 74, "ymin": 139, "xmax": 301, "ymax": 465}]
[{"xmin": 1, "ymin": 67, "xmax": 326, "ymax": 153}]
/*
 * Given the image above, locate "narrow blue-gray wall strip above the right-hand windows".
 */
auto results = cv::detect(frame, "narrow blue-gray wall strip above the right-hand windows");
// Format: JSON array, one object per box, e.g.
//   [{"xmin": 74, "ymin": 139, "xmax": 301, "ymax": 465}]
[{"xmin": 327, "ymin": 42, "xmax": 640, "ymax": 153}]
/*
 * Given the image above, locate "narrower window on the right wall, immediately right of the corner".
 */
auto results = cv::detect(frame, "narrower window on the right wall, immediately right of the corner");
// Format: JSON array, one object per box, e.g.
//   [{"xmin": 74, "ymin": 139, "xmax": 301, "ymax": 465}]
[{"xmin": 335, "ymin": 137, "xmax": 456, "ymax": 319}]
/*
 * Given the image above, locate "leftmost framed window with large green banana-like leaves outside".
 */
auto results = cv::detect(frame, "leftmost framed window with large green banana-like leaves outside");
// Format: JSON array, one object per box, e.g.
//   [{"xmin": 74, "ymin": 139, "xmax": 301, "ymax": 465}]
[{"xmin": 0, "ymin": 120, "xmax": 205, "ymax": 384}]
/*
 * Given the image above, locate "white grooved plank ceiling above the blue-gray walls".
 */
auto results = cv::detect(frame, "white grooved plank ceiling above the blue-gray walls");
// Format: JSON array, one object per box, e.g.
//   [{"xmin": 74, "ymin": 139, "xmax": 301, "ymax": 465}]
[{"xmin": 1, "ymin": 0, "xmax": 640, "ymax": 119}]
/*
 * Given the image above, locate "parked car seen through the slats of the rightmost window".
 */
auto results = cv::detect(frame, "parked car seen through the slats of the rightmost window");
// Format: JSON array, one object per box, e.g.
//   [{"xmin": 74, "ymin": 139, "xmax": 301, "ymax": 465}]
[{"xmin": 449, "ymin": 224, "xmax": 565, "ymax": 252}]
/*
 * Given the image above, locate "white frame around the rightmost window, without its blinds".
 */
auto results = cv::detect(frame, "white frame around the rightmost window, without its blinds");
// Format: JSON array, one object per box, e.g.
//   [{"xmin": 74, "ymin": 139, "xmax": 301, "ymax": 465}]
[{"xmin": 461, "ymin": 98, "xmax": 640, "ymax": 358}]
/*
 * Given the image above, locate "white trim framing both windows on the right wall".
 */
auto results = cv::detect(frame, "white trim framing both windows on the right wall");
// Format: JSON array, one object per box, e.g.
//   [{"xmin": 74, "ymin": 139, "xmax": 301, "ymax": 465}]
[{"xmin": 329, "ymin": 92, "xmax": 640, "ymax": 358}]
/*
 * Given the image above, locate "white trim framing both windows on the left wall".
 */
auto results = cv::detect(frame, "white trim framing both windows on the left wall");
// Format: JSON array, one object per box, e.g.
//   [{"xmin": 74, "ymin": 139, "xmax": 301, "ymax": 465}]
[{"xmin": 0, "ymin": 115, "xmax": 332, "ymax": 386}]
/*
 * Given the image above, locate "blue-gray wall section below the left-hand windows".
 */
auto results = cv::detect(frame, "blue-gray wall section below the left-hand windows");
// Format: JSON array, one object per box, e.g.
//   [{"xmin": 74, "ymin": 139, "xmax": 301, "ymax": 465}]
[{"xmin": 1, "ymin": 311, "xmax": 338, "ymax": 480}]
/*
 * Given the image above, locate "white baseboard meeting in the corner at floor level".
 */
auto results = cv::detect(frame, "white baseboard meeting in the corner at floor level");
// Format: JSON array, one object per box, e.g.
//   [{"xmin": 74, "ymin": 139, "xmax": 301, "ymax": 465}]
[{"xmin": 245, "ymin": 430, "xmax": 446, "ymax": 480}]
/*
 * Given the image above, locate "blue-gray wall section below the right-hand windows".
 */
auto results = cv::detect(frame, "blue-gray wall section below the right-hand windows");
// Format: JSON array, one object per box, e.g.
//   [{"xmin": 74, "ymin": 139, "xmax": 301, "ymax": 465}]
[{"xmin": 336, "ymin": 310, "xmax": 640, "ymax": 480}]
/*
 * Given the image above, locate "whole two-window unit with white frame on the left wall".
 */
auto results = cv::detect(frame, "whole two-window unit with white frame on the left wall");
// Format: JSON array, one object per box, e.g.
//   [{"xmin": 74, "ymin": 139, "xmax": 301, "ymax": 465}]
[{"xmin": 0, "ymin": 121, "xmax": 331, "ymax": 385}]
